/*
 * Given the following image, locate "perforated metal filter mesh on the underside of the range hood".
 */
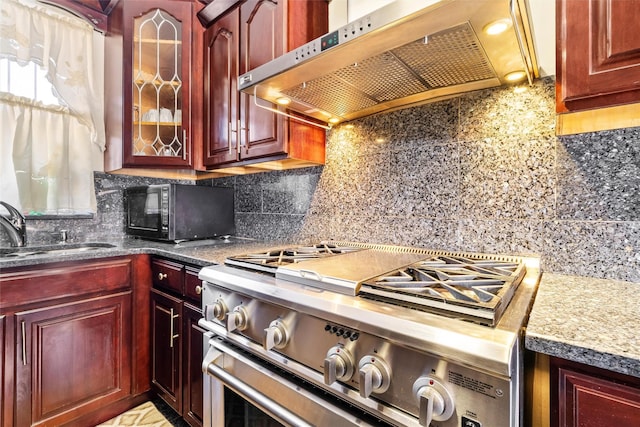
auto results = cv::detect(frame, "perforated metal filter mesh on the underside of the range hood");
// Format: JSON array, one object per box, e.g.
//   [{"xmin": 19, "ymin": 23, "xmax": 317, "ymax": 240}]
[{"xmin": 282, "ymin": 22, "xmax": 498, "ymax": 116}]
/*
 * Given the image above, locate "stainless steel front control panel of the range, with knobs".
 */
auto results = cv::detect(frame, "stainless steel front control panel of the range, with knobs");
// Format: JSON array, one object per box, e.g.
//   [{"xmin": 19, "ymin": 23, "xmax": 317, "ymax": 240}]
[{"xmin": 203, "ymin": 283, "xmax": 515, "ymax": 427}]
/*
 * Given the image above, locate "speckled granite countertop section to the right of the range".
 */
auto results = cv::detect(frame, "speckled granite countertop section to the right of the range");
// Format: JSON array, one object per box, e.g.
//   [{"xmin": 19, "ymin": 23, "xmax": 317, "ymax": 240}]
[{"xmin": 525, "ymin": 273, "xmax": 640, "ymax": 377}]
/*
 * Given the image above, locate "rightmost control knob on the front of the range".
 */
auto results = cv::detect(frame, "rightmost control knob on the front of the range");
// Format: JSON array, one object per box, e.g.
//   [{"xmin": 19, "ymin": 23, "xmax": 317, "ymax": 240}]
[{"xmin": 413, "ymin": 377, "xmax": 454, "ymax": 426}]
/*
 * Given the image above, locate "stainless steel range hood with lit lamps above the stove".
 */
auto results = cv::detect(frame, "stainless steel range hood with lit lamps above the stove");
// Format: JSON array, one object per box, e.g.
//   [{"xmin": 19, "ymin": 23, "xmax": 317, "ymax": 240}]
[{"xmin": 239, "ymin": 0, "xmax": 538, "ymax": 123}]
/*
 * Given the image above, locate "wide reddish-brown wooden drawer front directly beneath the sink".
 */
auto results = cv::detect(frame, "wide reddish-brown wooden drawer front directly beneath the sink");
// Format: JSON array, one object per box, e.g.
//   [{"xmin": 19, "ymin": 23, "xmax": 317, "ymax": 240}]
[{"xmin": 0, "ymin": 258, "xmax": 132, "ymax": 310}]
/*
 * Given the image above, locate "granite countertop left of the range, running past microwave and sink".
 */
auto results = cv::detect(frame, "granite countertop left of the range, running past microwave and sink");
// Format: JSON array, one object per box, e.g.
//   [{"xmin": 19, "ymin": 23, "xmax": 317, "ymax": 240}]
[{"xmin": 0, "ymin": 237, "xmax": 288, "ymax": 270}]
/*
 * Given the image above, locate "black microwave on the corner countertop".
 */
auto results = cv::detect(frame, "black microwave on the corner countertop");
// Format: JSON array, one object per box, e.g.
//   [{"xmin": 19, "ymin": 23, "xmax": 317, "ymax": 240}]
[{"xmin": 125, "ymin": 184, "xmax": 235, "ymax": 242}]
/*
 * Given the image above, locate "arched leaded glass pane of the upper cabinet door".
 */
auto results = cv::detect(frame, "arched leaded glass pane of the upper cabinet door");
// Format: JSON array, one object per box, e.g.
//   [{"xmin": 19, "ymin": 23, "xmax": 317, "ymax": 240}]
[{"xmin": 132, "ymin": 9, "xmax": 185, "ymax": 157}]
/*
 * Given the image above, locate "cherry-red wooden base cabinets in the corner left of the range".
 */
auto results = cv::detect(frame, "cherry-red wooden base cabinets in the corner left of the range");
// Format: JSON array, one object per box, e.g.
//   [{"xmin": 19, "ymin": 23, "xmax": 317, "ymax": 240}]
[{"xmin": 0, "ymin": 255, "xmax": 204, "ymax": 427}]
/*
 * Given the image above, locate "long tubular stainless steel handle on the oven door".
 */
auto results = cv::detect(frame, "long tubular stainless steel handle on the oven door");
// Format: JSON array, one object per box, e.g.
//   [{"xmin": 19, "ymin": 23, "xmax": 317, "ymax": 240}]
[{"xmin": 202, "ymin": 342, "xmax": 312, "ymax": 427}]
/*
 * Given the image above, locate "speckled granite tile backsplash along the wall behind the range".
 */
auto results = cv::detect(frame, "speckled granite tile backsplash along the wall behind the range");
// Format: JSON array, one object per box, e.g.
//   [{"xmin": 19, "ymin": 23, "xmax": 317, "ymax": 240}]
[{"xmin": 6, "ymin": 78, "xmax": 640, "ymax": 282}]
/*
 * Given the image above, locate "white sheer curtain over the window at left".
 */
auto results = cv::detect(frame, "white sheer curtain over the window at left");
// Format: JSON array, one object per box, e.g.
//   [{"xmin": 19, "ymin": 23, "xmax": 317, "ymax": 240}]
[{"xmin": 0, "ymin": 0, "xmax": 105, "ymax": 214}]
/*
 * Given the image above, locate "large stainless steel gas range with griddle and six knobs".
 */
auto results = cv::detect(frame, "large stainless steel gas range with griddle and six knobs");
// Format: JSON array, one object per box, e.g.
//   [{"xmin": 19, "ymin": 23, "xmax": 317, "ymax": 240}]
[{"xmin": 200, "ymin": 241, "xmax": 540, "ymax": 427}]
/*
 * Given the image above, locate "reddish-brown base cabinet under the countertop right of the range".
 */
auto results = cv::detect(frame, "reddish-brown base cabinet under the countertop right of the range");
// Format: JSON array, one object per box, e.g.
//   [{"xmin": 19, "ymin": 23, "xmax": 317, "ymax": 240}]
[{"xmin": 550, "ymin": 358, "xmax": 640, "ymax": 427}]
